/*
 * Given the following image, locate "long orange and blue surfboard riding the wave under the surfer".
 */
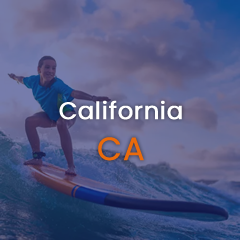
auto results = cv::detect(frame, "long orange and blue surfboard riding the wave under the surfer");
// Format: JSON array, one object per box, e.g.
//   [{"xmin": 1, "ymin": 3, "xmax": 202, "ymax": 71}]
[{"xmin": 27, "ymin": 163, "xmax": 228, "ymax": 221}]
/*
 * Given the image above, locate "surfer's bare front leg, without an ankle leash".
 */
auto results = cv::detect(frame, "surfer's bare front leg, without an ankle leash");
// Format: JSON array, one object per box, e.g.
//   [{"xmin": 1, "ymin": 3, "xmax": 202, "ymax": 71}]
[{"xmin": 57, "ymin": 112, "xmax": 76, "ymax": 175}]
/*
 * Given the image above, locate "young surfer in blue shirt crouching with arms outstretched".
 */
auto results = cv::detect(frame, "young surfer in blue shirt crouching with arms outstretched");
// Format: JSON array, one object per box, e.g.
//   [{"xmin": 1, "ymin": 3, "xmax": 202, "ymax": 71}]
[{"xmin": 8, "ymin": 56, "xmax": 110, "ymax": 175}]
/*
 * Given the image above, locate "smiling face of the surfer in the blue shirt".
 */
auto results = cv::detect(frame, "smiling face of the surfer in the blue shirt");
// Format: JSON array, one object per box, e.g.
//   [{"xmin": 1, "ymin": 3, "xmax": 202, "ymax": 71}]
[{"xmin": 38, "ymin": 59, "xmax": 57, "ymax": 81}]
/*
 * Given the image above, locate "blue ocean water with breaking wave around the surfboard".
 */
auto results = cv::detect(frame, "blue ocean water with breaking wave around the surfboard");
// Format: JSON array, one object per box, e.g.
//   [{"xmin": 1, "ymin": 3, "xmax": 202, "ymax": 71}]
[{"xmin": 0, "ymin": 131, "xmax": 240, "ymax": 240}]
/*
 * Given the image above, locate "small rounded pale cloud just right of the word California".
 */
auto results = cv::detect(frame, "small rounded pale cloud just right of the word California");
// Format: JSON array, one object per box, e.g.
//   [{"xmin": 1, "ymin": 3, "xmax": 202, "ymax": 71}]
[{"xmin": 183, "ymin": 98, "xmax": 218, "ymax": 130}]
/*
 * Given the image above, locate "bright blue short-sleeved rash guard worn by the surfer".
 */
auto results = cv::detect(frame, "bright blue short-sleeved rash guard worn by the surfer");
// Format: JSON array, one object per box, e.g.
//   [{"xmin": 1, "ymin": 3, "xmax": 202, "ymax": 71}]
[{"xmin": 23, "ymin": 75, "xmax": 74, "ymax": 121}]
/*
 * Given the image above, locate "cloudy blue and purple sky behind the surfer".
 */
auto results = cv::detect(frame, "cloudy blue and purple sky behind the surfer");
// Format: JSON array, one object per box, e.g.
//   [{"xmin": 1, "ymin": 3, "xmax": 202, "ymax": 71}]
[{"xmin": 0, "ymin": 0, "xmax": 240, "ymax": 181}]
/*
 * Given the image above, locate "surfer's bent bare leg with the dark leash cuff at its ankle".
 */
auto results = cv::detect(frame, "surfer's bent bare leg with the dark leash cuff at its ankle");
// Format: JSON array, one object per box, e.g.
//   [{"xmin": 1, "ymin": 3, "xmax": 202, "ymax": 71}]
[{"xmin": 24, "ymin": 112, "xmax": 56, "ymax": 165}]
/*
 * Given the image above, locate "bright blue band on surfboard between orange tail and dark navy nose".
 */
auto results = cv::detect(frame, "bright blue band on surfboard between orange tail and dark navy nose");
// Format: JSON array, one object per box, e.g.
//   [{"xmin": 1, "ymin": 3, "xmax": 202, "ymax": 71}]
[{"xmin": 75, "ymin": 187, "xmax": 108, "ymax": 204}]
